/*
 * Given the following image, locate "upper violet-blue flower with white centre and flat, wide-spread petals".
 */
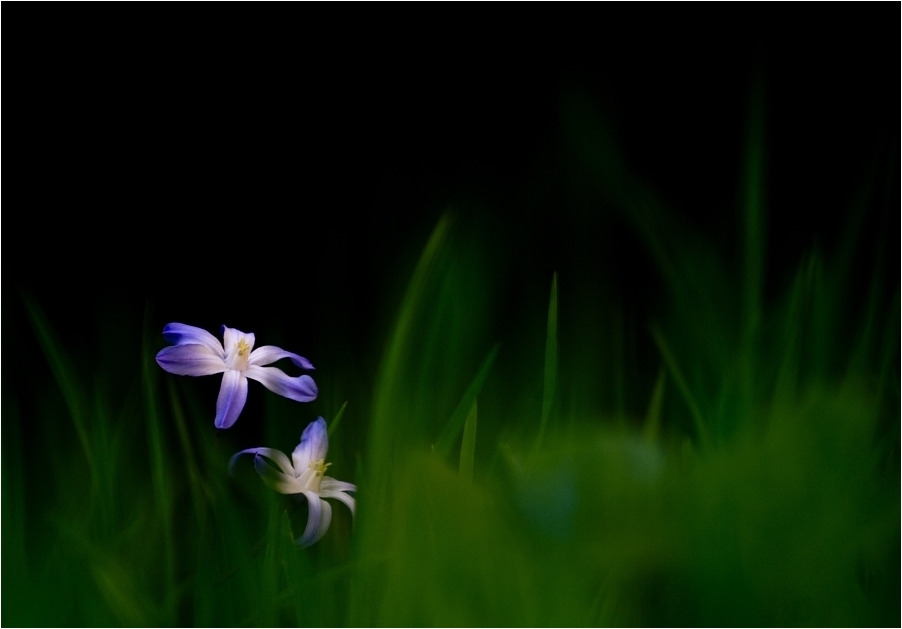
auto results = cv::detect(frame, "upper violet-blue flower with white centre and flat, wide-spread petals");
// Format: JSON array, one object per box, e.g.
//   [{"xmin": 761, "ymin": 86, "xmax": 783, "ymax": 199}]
[{"xmin": 157, "ymin": 323, "xmax": 317, "ymax": 428}]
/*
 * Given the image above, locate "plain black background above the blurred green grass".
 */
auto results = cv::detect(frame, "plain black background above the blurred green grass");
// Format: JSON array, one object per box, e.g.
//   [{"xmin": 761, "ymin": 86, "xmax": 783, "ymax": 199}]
[{"xmin": 3, "ymin": 9, "xmax": 900, "ymax": 440}]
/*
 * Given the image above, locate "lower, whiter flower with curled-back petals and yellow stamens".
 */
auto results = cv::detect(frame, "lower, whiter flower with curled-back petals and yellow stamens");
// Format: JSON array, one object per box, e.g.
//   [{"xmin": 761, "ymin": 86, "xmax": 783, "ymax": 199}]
[{"xmin": 229, "ymin": 417, "xmax": 357, "ymax": 547}]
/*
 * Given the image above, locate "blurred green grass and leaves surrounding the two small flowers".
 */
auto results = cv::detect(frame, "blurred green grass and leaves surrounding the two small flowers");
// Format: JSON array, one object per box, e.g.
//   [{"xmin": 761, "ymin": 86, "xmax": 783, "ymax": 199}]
[{"xmin": 2, "ymin": 91, "xmax": 900, "ymax": 626}]
